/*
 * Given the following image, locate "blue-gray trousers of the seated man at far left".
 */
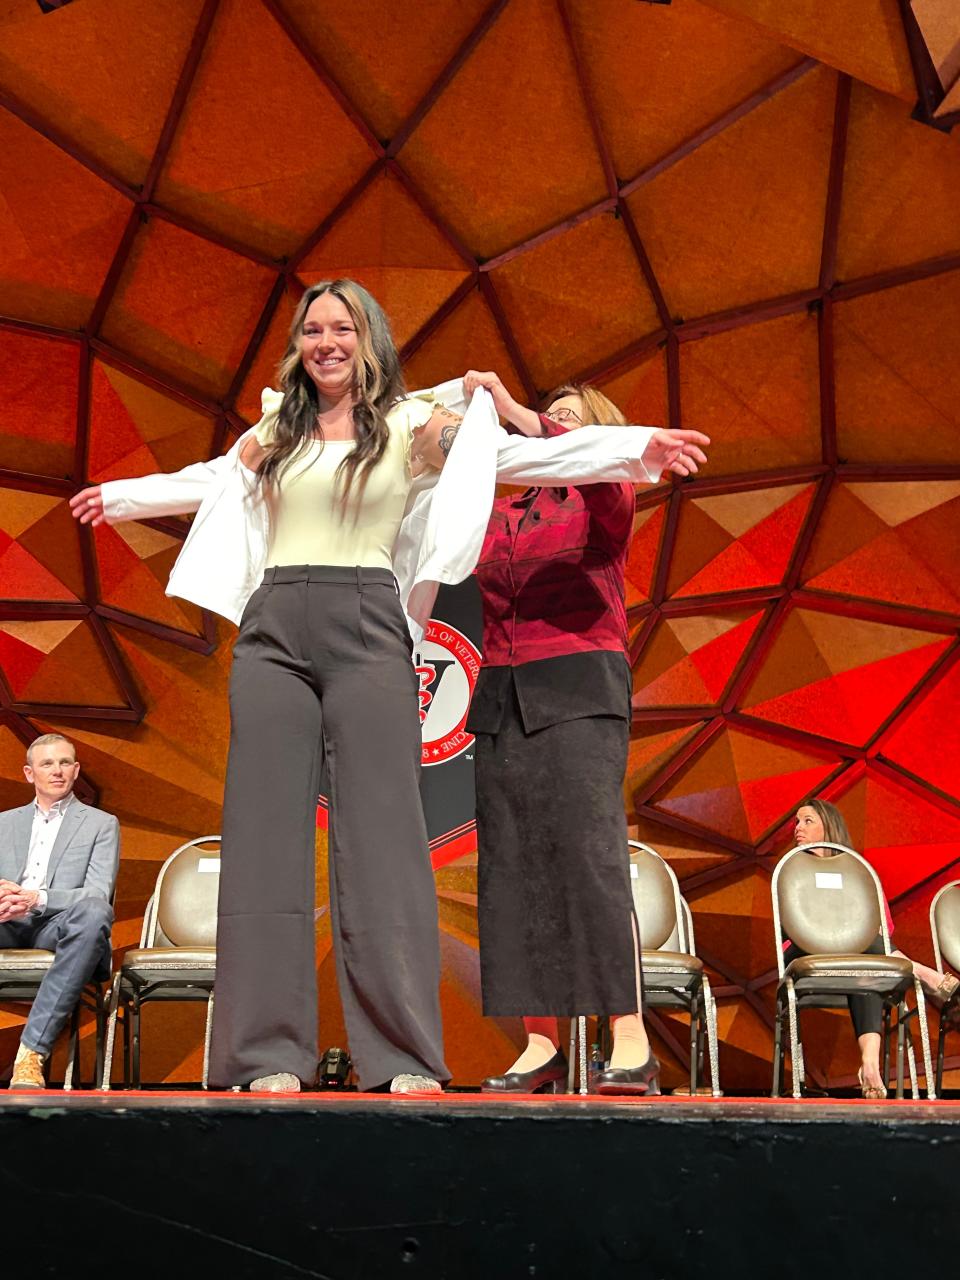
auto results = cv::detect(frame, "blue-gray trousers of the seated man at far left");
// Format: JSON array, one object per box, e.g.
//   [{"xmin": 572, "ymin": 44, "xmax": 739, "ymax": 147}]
[{"xmin": 0, "ymin": 897, "xmax": 114, "ymax": 1057}]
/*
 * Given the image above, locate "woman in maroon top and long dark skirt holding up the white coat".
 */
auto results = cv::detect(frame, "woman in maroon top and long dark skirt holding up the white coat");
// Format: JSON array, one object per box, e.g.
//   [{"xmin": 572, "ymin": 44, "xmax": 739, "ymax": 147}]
[{"xmin": 465, "ymin": 372, "xmax": 709, "ymax": 1093}]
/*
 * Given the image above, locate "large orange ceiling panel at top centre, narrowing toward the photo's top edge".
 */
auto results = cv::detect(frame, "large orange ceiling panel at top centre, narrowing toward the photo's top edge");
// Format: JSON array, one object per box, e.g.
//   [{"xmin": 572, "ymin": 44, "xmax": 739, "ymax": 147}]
[{"xmin": 399, "ymin": 0, "xmax": 605, "ymax": 257}]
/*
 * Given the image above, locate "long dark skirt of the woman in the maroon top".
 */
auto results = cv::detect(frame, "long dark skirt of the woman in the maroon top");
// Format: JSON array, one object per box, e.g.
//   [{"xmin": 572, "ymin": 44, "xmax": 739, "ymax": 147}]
[{"xmin": 475, "ymin": 655, "xmax": 639, "ymax": 1016}]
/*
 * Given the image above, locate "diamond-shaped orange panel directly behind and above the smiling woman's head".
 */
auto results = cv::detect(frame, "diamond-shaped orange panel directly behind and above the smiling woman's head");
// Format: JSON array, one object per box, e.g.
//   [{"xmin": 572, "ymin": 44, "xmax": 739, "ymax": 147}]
[{"xmin": 297, "ymin": 173, "xmax": 470, "ymax": 346}]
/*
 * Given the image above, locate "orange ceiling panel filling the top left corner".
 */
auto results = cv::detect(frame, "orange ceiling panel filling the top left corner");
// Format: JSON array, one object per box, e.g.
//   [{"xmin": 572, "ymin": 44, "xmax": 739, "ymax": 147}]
[{"xmin": 0, "ymin": 0, "xmax": 202, "ymax": 186}]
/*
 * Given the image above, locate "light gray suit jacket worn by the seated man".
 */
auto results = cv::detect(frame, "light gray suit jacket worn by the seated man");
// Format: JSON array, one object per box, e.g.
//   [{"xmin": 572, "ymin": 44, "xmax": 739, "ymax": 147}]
[{"xmin": 0, "ymin": 796, "xmax": 120, "ymax": 915}]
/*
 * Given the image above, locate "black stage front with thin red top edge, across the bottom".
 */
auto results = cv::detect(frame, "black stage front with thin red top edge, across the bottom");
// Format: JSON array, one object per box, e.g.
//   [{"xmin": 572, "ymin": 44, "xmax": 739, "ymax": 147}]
[{"xmin": 0, "ymin": 1092, "xmax": 960, "ymax": 1280}]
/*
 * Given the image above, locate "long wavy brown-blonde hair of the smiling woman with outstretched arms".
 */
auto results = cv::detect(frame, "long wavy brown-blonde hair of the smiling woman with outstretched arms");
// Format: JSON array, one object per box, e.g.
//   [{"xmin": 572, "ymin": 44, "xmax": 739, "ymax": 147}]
[{"xmin": 257, "ymin": 279, "xmax": 404, "ymax": 500}]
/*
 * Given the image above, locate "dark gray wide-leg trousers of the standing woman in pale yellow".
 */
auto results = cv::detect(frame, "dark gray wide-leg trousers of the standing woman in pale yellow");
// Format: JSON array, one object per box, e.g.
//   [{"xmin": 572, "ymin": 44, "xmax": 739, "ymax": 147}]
[{"xmin": 210, "ymin": 566, "xmax": 449, "ymax": 1089}]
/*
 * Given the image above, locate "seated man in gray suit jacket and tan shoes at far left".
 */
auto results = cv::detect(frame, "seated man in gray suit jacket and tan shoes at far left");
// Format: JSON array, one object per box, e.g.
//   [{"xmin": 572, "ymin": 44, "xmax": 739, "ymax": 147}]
[{"xmin": 0, "ymin": 733, "xmax": 120, "ymax": 1089}]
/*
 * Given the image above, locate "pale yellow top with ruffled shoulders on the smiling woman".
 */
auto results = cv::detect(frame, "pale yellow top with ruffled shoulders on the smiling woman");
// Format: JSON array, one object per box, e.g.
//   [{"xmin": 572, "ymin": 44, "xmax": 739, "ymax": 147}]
[{"xmin": 256, "ymin": 398, "xmax": 433, "ymax": 570}]
